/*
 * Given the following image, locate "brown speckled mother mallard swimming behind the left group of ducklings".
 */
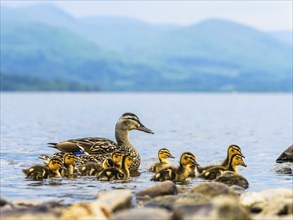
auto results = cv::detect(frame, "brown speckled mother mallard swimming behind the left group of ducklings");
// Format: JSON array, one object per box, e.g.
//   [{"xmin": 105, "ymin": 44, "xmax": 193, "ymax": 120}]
[{"xmin": 49, "ymin": 113, "xmax": 153, "ymax": 172}]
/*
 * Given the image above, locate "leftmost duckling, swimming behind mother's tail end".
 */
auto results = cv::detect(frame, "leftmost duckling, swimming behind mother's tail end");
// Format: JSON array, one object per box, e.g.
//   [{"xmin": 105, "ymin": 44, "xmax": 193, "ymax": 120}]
[{"xmin": 22, "ymin": 157, "xmax": 62, "ymax": 180}]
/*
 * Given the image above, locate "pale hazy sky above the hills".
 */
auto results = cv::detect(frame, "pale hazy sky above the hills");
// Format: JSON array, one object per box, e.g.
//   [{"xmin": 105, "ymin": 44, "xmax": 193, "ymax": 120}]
[{"xmin": 1, "ymin": 0, "xmax": 293, "ymax": 31}]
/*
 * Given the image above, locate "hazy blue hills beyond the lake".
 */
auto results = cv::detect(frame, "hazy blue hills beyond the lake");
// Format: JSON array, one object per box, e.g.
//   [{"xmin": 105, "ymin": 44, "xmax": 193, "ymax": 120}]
[{"xmin": 0, "ymin": 5, "xmax": 292, "ymax": 91}]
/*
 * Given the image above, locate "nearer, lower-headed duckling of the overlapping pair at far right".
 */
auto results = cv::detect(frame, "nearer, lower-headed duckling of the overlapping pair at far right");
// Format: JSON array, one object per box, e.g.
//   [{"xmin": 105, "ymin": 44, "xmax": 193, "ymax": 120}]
[{"xmin": 199, "ymin": 154, "xmax": 247, "ymax": 180}]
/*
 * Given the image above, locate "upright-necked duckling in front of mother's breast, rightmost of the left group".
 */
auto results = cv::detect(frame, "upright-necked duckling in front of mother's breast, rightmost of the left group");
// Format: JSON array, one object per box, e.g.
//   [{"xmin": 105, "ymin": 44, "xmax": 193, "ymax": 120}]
[{"xmin": 97, "ymin": 155, "xmax": 133, "ymax": 181}]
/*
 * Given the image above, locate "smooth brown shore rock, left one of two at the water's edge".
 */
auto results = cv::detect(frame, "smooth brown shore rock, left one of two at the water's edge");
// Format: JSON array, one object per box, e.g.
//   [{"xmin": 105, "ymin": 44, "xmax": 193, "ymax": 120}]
[{"xmin": 136, "ymin": 180, "xmax": 178, "ymax": 199}]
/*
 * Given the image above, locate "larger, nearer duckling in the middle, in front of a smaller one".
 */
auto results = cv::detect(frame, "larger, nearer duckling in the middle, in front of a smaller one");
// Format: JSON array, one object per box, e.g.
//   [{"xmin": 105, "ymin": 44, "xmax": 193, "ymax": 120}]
[{"xmin": 151, "ymin": 152, "xmax": 198, "ymax": 182}]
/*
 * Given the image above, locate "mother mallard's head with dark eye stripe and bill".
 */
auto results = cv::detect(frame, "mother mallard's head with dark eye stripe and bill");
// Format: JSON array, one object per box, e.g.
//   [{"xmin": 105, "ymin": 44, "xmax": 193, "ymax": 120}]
[{"xmin": 116, "ymin": 112, "xmax": 154, "ymax": 134}]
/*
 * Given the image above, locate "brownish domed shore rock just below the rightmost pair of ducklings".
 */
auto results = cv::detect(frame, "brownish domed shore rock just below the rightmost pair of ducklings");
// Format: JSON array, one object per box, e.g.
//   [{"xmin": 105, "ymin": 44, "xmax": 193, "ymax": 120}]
[{"xmin": 191, "ymin": 182, "xmax": 238, "ymax": 198}]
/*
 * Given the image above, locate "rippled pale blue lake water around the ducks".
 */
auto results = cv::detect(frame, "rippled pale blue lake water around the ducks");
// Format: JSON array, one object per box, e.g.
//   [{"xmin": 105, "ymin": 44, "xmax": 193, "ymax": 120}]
[{"xmin": 1, "ymin": 93, "xmax": 293, "ymax": 203}]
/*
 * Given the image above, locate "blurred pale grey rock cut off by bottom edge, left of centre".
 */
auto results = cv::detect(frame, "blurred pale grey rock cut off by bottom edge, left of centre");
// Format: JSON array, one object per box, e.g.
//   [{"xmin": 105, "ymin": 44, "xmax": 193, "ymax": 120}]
[{"xmin": 110, "ymin": 208, "xmax": 171, "ymax": 220}]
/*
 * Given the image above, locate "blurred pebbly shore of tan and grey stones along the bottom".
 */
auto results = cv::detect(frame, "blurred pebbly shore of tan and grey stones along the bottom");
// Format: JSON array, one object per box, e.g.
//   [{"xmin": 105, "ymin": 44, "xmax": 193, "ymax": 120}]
[{"xmin": 0, "ymin": 181, "xmax": 293, "ymax": 220}]
